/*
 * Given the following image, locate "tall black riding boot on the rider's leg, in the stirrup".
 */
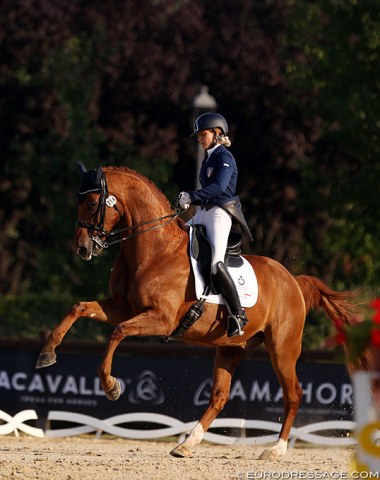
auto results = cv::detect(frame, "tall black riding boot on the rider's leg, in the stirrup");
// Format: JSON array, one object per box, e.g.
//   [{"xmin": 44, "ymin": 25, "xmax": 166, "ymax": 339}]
[{"xmin": 214, "ymin": 262, "xmax": 248, "ymax": 337}]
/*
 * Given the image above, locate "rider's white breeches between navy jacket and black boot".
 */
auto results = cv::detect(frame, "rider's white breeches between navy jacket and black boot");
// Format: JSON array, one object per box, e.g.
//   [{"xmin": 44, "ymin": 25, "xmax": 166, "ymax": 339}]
[{"xmin": 187, "ymin": 206, "xmax": 232, "ymax": 273}]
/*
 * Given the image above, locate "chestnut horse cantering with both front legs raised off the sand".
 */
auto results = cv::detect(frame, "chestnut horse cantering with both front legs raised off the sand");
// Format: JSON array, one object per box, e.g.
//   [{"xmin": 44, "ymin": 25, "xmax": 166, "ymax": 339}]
[{"xmin": 36, "ymin": 166, "xmax": 353, "ymax": 457}]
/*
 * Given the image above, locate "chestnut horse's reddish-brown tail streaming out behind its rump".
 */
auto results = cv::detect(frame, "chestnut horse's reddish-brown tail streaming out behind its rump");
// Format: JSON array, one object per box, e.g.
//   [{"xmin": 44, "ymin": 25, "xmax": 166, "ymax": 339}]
[{"xmin": 295, "ymin": 275, "xmax": 369, "ymax": 371}]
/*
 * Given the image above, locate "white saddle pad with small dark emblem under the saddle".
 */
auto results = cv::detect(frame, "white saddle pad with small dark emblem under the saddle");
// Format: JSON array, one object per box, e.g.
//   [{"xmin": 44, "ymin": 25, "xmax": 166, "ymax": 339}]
[{"xmin": 189, "ymin": 226, "xmax": 258, "ymax": 308}]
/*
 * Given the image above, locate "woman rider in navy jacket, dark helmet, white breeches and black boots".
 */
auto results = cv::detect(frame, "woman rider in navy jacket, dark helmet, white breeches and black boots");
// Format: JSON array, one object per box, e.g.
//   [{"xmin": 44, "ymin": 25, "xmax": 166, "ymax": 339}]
[{"xmin": 177, "ymin": 113, "xmax": 252, "ymax": 337}]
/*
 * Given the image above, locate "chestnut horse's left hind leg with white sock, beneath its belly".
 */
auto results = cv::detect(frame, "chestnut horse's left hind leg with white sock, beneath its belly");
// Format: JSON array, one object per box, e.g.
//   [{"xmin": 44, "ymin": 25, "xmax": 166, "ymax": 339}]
[{"xmin": 170, "ymin": 347, "xmax": 245, "ymax": 458}]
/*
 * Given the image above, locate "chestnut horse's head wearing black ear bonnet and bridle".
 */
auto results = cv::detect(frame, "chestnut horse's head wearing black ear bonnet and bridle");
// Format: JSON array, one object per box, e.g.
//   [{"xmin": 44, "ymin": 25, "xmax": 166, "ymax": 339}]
[{"xmin": 73, "ymin": 164, "xmax": 121, "ymax": 260}]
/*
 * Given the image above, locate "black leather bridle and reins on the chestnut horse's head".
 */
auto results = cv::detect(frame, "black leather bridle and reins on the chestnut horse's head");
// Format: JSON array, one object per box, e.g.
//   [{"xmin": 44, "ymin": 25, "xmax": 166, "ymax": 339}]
[{"xmin": 77, "ymin": 173, "xmax": 184, "ymax": 248}]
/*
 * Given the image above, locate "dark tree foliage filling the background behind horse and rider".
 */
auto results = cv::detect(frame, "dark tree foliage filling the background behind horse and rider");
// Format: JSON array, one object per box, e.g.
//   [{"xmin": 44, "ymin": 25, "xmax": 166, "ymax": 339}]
[{"xmin": 0, "ymin": 0, "xmax": 380, "ymax": 347}]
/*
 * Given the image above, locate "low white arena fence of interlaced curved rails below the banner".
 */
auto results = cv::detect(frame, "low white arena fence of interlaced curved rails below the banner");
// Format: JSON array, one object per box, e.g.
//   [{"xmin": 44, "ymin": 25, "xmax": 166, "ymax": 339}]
[{"xmin": 0, "ymin": 410, "xmax": 357, "ymax": 447}]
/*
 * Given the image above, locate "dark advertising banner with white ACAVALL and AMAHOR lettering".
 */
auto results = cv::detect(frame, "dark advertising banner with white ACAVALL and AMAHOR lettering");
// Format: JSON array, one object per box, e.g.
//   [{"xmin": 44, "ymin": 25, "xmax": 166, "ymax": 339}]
[{"xmin": 0, "ymin": 350, "xmax": 353, "ymax": 426}]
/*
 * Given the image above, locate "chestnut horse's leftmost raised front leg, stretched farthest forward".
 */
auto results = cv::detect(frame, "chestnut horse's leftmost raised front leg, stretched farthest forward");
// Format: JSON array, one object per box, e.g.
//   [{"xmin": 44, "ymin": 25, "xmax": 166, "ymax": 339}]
[{"xmin": 36, "ymin": 299, "xmax": 125, "ymax": 368}]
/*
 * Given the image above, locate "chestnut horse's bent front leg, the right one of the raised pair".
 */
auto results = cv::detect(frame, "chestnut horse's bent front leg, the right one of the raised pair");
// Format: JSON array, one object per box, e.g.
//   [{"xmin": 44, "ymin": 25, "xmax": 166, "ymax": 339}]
[{"xmin": 98, "ymin": 309, "xmax": 175, "ymax": 400}]
